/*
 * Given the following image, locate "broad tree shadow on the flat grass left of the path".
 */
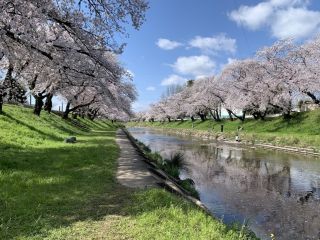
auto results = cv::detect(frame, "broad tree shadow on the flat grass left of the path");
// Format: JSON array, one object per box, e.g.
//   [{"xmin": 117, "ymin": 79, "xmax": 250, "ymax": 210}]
[{"xmin": 0, "ymin": 131, "xmax": 198, "ymax": 239}]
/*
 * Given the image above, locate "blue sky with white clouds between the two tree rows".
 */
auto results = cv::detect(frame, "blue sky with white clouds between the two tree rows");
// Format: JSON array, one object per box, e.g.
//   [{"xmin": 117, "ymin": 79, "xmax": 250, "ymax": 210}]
[{"xmin": 120, "ymin": 0, "xmax": 320, "ymax": 111}]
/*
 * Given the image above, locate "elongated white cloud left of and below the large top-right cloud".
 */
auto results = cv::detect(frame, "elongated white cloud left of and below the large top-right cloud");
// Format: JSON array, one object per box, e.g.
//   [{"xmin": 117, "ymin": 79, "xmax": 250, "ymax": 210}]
[{"xmin": 189, "ymin": 34, "xmax": 237, "ymax": 53}]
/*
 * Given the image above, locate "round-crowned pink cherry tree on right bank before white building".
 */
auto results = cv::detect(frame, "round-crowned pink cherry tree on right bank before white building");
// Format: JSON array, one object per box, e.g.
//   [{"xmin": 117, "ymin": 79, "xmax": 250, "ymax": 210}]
[{"xmin": 216, "ymin": 59, "xmax": 270, "ymax": 121}]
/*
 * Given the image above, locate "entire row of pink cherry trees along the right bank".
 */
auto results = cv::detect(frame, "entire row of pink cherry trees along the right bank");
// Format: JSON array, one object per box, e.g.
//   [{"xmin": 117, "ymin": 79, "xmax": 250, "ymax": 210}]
[{"xmin": 141, "ymin": 37, "xmax": 320, "ymax": 121}]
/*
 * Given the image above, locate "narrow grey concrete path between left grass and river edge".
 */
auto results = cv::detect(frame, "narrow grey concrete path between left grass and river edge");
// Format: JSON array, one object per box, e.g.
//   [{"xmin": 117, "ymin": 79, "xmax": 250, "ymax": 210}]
[{"xmin": 116, "ymin": 129, "xmax": 157, "ymax": 188}]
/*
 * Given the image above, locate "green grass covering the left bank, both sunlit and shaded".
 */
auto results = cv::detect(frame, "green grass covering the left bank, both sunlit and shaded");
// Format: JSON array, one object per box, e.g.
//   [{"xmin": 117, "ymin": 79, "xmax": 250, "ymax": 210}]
[{"xmin": 0, "ymin": 105, "xmax": 255, "ymax": 239}]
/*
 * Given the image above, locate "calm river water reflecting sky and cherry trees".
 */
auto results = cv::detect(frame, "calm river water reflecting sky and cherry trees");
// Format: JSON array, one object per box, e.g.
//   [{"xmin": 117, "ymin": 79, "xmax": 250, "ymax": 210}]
[{"xmin": 128, "ymin": 128, "xmax": 320, "ymax": 240}]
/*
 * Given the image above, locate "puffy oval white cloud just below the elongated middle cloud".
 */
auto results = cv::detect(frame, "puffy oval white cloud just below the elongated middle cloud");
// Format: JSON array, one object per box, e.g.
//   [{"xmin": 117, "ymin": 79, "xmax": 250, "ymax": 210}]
[{"xmin": 172, "ymin": 55, "xmax": 216, "ymax": 78}]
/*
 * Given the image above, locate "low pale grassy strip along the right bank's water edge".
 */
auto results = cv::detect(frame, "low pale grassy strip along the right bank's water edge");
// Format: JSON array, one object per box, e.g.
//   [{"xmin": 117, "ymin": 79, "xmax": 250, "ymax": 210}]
[{"xmin": 127, "ymin": 122, "xmax": 320, "ymax": 156}]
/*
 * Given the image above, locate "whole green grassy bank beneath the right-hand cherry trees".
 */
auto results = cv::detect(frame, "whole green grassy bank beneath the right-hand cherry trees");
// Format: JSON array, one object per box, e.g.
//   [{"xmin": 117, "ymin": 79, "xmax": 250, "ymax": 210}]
[{"xmin": 127, "ymin": 110, "xmax": 320, "ymax": 151}]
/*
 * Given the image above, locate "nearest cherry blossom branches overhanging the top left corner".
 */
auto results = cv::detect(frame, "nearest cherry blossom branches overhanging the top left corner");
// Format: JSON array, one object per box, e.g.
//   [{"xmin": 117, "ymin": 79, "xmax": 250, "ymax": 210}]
[{"xmin": 0, "ymin": 0, "xmax": 148, "ymax": 63}]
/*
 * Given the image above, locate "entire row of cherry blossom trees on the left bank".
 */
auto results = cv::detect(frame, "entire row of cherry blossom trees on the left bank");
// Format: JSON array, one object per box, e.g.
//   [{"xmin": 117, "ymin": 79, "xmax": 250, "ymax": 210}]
[{"xmin": 0, "ymin": 0, "xmax": 148, "ymax": 118}]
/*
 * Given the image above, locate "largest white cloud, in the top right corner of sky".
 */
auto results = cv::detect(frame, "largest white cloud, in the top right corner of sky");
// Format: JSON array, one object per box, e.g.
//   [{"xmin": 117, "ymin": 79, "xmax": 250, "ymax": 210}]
[{"xmin": 229, "ymin": 0, "xmax": 320, "ymax": 39}]
